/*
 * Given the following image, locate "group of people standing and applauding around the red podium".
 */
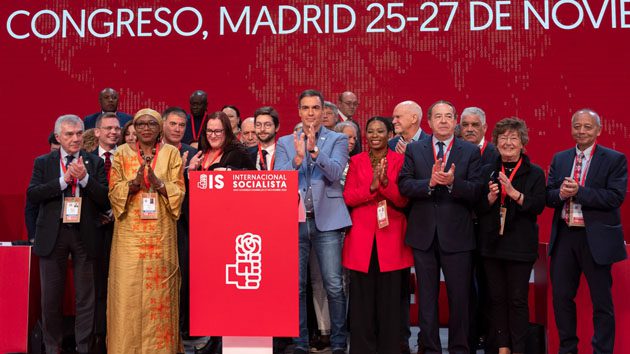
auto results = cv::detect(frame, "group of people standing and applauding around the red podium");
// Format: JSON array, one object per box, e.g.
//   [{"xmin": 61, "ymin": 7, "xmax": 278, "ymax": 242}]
[{"xmin": 27, "ymin": 89, "xmax": 627, "ymax": 354}]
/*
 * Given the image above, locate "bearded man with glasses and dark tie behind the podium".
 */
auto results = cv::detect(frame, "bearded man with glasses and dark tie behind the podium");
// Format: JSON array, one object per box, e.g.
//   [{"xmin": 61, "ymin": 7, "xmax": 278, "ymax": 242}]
[{"xmin": 247, "ymin": 106, "xmax": 280, "ymax": 171}]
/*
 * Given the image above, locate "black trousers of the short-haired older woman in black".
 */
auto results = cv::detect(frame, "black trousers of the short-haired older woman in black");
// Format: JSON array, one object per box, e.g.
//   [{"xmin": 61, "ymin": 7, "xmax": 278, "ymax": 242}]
[{"xmin": 484, "ymin": 257, "xmax": 534, "ymax": 353}]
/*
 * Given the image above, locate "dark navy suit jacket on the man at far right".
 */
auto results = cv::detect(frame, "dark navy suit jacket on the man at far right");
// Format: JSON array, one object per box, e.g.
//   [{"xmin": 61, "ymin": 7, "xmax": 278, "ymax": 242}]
[{"xmin": 547, "ymin": 145, "xmax": 628, "ymax": 265}]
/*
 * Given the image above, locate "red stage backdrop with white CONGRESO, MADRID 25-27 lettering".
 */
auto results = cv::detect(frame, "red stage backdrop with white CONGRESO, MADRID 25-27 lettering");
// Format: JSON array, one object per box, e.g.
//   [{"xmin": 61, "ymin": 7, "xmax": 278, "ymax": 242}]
[{"xmin": 0, "ymin": 0, "xmax": 630, "ymax": 240}]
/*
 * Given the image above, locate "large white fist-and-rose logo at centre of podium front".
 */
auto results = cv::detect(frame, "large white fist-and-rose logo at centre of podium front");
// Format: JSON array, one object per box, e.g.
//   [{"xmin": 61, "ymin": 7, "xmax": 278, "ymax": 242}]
[{"xmin": 225, "ymin": 232, "xmax": 262, "ymax": 290}]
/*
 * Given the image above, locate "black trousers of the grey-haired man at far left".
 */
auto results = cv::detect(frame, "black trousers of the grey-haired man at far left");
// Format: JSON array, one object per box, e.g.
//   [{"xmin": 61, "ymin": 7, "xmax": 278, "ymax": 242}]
[{"xmin": 39, "ymin": 223, "xmax": 95, "ymax": 353}]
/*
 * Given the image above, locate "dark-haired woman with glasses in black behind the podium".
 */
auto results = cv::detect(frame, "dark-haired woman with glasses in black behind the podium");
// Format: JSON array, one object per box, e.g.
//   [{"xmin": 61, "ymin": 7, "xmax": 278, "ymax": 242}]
[{"xmin": 189, "ymin": 112, "xmax": 256, "ymax": 171}]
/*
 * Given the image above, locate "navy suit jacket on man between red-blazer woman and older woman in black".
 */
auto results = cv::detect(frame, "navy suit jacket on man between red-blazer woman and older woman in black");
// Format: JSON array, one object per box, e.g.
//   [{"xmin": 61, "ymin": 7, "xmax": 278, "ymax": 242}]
[{"xmin": 398, "ymin": 138, "xmax": 481, "ymax": 252}]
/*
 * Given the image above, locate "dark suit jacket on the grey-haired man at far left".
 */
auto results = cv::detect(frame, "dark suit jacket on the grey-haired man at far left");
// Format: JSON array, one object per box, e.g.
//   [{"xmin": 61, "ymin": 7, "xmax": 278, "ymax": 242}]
[{"xmin": 27, "ymin": 151, "xmax": 110, "ymax": 257}]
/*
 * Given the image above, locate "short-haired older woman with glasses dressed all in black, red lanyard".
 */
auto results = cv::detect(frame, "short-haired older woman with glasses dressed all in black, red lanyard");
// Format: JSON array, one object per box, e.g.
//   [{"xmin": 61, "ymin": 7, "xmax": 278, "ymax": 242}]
[{"xmin": 475, "ymin": 118, "xmax": 546, "ymax": 354}]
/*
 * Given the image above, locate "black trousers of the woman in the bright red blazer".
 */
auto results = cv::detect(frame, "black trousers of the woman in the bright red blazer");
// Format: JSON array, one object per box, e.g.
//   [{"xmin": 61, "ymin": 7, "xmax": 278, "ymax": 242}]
[{"xmin": 349, "ymin": 244, "xmax": 409, "ymax": 354}]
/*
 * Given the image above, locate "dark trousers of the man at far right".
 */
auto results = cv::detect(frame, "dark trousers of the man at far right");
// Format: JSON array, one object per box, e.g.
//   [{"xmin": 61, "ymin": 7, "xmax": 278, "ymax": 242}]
[{"xmin": 550, "ymin": 221, "xmax": 615, "ymax": 354}]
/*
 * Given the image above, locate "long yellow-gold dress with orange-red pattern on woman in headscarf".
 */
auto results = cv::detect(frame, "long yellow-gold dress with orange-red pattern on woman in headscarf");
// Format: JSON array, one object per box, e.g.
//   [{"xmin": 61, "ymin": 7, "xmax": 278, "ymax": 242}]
[{"xmin": 107, "ymin": 144, "xmax": 186, "ymax": 354}]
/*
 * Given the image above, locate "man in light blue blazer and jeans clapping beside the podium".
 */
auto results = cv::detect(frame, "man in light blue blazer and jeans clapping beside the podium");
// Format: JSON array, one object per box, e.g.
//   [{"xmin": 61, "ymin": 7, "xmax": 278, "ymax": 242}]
[{"xmin": 274, "ymin": 90, "xmax": 352, "ymax": 354}]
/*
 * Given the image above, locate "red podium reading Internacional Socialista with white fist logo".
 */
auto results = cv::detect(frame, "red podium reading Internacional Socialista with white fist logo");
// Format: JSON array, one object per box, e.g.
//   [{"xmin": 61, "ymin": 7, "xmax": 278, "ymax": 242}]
[{"xmin": 189, "ymin": 171, "xmax": 299, "ymax": 354}]
